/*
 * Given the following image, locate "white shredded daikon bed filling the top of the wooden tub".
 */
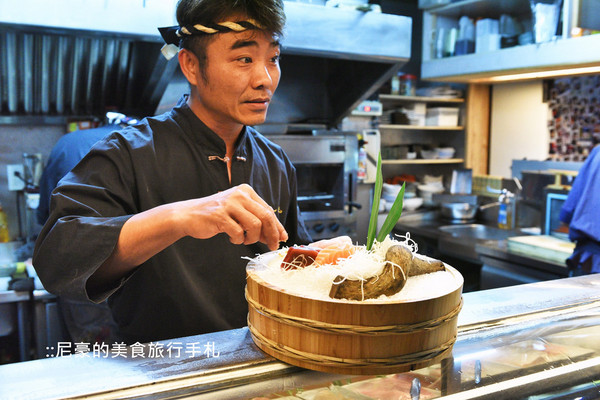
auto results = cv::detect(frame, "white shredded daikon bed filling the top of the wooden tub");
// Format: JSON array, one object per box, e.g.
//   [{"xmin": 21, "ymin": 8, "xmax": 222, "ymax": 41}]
[{"xmin": 247, "ymin": 234, "xmax": 458, "ymax": 302}]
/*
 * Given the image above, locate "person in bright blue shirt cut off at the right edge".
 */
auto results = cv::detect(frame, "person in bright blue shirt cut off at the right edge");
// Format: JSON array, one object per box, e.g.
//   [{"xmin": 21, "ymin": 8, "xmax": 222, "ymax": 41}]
[{"xmin": 559, "ymin": 146, "xmax": 600, "ymax": 275}]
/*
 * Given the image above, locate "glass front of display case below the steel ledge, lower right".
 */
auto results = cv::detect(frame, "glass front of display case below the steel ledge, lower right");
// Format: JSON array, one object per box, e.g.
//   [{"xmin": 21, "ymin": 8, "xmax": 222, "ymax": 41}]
[{"xmin": 220, "ymin": 304, "xmax": 600, "ymax": 400}]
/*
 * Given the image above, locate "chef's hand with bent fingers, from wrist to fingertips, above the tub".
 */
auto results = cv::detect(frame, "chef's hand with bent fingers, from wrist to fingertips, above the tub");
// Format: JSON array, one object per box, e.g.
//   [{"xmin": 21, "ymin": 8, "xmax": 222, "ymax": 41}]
[{"xmin": 179, "ymin": 184, "xmax": 288, "ymax": 250}]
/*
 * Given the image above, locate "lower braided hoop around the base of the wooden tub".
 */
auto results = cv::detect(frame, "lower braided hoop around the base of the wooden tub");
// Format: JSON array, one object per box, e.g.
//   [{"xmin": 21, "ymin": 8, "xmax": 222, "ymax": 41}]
[{"xmin": 248, "ymin": 320, "xmax": 456, "ymax": 368}]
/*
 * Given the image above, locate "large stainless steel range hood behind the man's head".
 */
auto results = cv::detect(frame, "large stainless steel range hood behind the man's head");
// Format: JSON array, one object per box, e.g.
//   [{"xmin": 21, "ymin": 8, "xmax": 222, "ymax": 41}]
[{"xmin": 0, "ymin": 0, "xmax": 411, "ymax": 126}]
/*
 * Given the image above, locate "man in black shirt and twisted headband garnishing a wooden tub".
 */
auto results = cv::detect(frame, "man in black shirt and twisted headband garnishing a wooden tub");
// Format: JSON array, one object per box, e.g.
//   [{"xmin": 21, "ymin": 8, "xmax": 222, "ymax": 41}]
[{"xmin": 33, "ymin": 0, "xmax": 310, "ymax": 343}]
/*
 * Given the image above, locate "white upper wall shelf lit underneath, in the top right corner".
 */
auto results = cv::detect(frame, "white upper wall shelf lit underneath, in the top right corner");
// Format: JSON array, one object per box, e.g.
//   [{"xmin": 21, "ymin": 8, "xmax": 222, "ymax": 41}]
[{"xmin": 421, "ymin": 0, "xmax": 600, "ymax": 83}]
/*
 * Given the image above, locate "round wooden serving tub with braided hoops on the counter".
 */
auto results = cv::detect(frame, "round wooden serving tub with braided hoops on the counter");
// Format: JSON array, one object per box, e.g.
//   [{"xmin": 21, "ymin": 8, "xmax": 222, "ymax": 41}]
[{"xmin": 246, "ymin": 253, "xmax": 464, "ymax": 375}]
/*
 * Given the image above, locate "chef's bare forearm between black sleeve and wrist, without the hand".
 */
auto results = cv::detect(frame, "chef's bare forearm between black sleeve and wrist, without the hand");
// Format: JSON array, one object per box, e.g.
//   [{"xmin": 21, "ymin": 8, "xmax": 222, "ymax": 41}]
[{"xmin": 87, "ymin": 204, "xmax": 185, "ymax": 293}]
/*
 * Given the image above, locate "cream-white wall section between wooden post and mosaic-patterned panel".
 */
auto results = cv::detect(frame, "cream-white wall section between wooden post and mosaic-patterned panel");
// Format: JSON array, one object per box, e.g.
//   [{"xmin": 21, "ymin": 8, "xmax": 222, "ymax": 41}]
[{"xmin": 489, "ymin": 80, "xmax": 550, "ymax": 178}]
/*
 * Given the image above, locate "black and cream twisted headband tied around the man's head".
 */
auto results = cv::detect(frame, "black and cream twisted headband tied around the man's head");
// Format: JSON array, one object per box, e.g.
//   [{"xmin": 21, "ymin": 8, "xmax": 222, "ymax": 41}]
[{"xmin": 158, "ymin": 19, "xmax": 264, "ymax": 60}]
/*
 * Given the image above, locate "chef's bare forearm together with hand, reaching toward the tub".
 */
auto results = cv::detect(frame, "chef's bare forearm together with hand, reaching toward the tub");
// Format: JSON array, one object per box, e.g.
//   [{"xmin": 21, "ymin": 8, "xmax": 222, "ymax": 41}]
[{"xmin": 86, "ymin": 184, "xmax": 288, "ymax": 294}]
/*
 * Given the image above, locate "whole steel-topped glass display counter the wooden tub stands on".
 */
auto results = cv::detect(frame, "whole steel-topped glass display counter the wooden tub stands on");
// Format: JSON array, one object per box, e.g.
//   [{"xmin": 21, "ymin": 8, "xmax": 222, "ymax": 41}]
[{"xmin": 0, "ymin": 274, "xmax": 600, "ymax": 400}]
